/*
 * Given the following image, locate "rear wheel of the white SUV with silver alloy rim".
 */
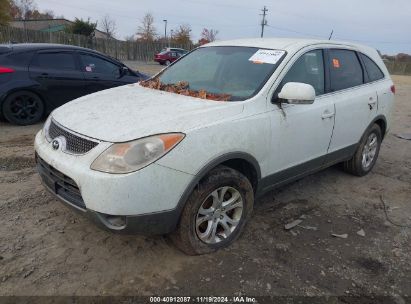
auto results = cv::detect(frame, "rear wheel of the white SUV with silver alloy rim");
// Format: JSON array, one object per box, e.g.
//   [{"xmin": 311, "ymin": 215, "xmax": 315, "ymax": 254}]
[{"xmin": 343, "ymin": 124, "xmax": 382, "ymax": 176}]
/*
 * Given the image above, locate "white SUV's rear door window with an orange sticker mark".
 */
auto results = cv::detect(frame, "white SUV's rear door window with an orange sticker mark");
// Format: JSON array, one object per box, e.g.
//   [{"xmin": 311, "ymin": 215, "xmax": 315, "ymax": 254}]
[{"xmin": 329, "ymin": 49, "xmax": 364, "ymax": 91}]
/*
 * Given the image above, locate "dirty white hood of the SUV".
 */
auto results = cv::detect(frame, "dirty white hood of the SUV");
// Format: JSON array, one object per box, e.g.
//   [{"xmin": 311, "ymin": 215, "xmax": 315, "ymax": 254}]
[{"xmin": 52, "ymin": 84, "xmax": 243, "ymax": 142}]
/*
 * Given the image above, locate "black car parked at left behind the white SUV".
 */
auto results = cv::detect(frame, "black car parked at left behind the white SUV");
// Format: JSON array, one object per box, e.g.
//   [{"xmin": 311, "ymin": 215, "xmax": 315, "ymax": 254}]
[{"xmin": 0, "ymin": 43, "xmax": 147, "ymax": 125}]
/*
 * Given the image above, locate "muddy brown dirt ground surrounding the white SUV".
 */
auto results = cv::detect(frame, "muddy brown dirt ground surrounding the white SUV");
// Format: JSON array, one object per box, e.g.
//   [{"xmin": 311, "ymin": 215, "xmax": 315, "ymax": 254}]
[{"xmin": 0, "ymin": 69, "xmax": 411, "ymax": 303}]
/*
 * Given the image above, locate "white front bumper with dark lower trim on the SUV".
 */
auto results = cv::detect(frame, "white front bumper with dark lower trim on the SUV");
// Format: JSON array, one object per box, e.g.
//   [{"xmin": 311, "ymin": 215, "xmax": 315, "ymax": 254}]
[{"xmin": 35, "ymin": 131, "xmax": 192, "ymax": 234}]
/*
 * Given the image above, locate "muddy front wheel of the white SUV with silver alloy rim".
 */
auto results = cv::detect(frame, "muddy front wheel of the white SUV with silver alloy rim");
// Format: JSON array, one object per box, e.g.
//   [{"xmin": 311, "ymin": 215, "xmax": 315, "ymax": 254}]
[{"xmin": 170, "ymin": 166, "xmax": 254, "ymax": 255}]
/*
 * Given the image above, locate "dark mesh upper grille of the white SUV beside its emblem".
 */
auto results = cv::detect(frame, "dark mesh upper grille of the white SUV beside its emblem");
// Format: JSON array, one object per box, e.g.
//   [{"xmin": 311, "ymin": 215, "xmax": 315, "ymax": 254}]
[{"xmin": 48, "ymin": 120, "xmax": 98, "ymax": 154}]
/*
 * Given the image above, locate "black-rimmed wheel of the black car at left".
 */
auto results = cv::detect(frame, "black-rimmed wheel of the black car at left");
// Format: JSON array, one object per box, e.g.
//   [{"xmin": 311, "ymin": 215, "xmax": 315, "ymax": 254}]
[{"xmin": 2, "ymin": 91, "xmax": 44, "ymax": 126}]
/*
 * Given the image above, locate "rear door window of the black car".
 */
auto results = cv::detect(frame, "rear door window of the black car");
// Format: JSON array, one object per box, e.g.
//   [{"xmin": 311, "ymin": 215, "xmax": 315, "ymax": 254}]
[{"xmin": 32, "ymin": 52, "xmax": 76, "ymax": 71}]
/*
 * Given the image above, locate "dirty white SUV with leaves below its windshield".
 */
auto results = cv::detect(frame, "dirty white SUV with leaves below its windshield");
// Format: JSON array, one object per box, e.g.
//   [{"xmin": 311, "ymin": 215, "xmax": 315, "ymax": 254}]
[{"xmin": 35, "ymin": 39, "xmax": 395, "ymax": 254}]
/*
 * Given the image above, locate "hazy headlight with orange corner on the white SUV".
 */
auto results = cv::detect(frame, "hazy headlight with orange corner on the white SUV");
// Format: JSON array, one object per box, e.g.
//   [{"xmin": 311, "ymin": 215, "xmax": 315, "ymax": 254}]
[{"xmin": 91, "ymin": 133, "xmax": 185, "ymax": 173}]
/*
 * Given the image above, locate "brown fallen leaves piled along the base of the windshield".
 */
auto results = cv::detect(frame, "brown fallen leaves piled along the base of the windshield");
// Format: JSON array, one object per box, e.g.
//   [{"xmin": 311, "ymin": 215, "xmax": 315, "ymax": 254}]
[{"xmin": 140, "ymin": 77, "xmax": 231, "ymax": 101}]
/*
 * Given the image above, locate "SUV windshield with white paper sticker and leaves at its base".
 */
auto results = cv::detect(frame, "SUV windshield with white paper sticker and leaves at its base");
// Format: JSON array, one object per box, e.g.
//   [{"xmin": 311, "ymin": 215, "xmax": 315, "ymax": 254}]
[{"xmin": 142, "ymin": 46, "xmax": 285, "ymax": 101}]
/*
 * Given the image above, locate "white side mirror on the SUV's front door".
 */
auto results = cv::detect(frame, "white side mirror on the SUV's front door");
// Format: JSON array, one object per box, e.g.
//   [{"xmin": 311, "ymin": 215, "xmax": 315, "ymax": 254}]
[{"xmin": 278, "ymin": 82, "xmax": 315, "ymax": 104}]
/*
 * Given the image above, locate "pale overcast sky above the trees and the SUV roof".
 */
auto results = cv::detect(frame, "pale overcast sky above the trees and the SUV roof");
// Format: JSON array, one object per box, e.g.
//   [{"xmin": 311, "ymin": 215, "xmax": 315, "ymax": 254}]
[{"xmin": 35, "ymin": 0, "xmax": 411, "ymax": 54}]
